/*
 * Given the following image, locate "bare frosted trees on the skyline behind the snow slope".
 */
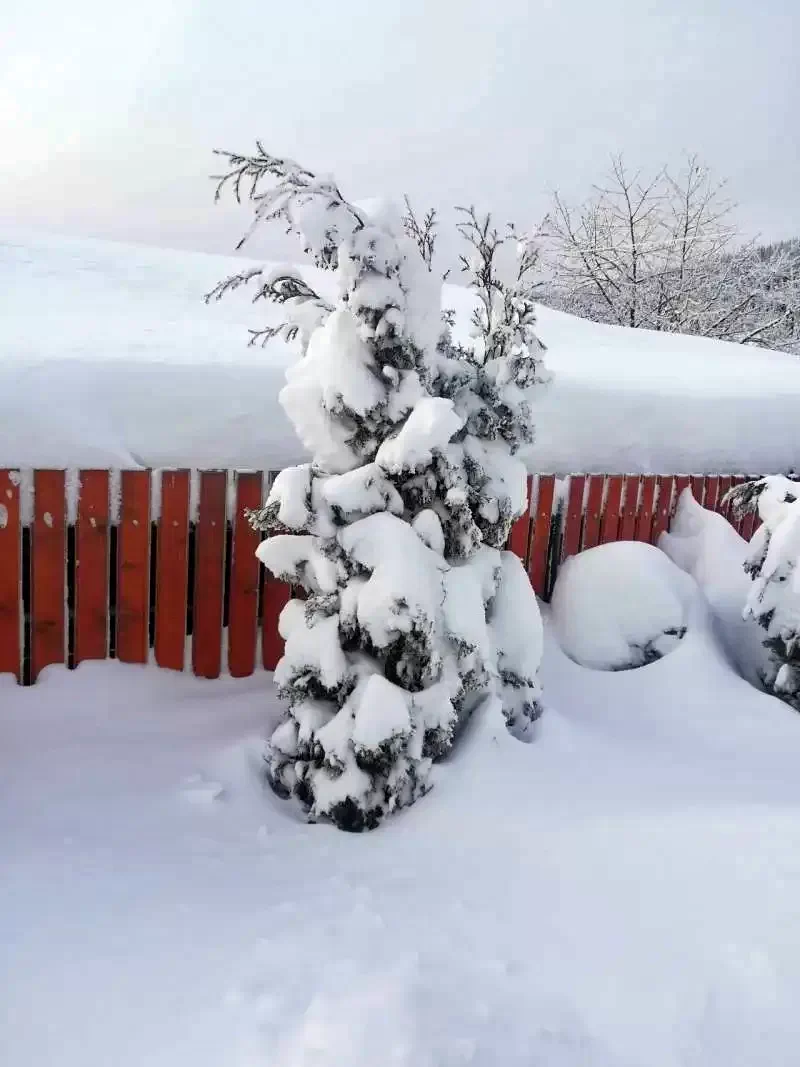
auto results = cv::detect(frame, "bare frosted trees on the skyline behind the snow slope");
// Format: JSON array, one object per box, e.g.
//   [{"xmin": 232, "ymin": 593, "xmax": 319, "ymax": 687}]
[{"xmin": 543, "ymin": 156, "xmax": 800, "ymax": 348}]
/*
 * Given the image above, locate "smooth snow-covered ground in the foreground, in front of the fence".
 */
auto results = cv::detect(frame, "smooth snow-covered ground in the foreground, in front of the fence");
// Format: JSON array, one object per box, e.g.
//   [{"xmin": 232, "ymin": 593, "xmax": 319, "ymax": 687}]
[{"xmin": 0, "ymin": 588, "xmax": 800, "ymax": 1067}]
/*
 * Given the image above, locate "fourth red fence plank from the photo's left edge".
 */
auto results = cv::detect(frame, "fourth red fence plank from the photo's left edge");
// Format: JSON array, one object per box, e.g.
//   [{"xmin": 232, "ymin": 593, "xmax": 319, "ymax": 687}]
[{"xmin": 116, "ymin": 471, "xmax": 150, "ymax": 664}]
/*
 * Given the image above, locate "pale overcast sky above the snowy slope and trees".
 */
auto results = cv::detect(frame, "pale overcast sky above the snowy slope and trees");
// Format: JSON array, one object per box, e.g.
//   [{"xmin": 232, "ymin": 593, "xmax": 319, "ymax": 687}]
[{"xmin": 0, "ymin": 0, "xmax": 800, "ymax": 252}]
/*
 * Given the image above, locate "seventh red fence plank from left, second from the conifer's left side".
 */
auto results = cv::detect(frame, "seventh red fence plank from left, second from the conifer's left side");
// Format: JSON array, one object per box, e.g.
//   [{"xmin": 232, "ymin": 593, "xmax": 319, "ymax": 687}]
[{"xmin": 228, "ymin": 474, "xmax": 261, "ymax": 678}]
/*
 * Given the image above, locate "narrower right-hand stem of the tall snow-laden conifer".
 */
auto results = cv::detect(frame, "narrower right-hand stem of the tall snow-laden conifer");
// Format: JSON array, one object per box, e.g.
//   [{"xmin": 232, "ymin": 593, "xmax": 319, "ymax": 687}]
[{"xmin": 435, "ymin": 207, "xmax": 550, "ymax": 738}]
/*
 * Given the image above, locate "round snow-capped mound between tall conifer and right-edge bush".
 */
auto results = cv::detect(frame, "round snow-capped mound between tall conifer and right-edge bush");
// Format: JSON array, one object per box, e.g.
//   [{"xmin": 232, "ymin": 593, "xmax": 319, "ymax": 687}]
[{"xmin": 550, "ymin": 541, "xmax": 693, "ymax": 670}]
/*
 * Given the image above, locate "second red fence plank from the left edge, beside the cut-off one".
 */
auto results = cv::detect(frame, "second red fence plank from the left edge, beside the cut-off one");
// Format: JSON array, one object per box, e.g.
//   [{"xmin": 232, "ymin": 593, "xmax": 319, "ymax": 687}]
[{"xmin": 31, "ymin": 471, "xmax": 66, "ymax": 682}]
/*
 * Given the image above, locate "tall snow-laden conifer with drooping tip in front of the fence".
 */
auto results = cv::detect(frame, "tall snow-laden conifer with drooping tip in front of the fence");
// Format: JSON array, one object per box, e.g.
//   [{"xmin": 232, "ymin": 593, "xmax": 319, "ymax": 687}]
[{"xmin": 209, "ymin": 145, "xmax": 543, "ymax": 830}]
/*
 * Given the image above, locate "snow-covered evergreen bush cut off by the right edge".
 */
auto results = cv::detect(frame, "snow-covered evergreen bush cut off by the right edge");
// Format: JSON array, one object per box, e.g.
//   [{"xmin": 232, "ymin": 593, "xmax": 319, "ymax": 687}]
[{"xmin": 729, "ymin": 475, "xmax": 800, "ymax": 711}]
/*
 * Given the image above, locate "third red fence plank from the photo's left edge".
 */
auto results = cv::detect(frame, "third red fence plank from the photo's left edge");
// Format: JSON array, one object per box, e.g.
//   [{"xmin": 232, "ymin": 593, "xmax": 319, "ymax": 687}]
[{"xmin": 75, "ymin": 471, "xmax": 109, "ymax": 666}]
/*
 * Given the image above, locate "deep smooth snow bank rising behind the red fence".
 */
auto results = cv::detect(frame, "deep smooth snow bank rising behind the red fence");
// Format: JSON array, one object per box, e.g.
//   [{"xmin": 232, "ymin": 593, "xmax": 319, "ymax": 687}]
[{"xmin": 0, "ymin": 235, "xmax": 800, "ymax": 474}]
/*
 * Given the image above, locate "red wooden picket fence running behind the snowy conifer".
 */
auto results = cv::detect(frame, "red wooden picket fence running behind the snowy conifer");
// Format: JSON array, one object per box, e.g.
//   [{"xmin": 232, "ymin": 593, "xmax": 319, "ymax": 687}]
[{"xmin": 0, "ymin": 471, "xmax": 754, "ymax": 684}]
